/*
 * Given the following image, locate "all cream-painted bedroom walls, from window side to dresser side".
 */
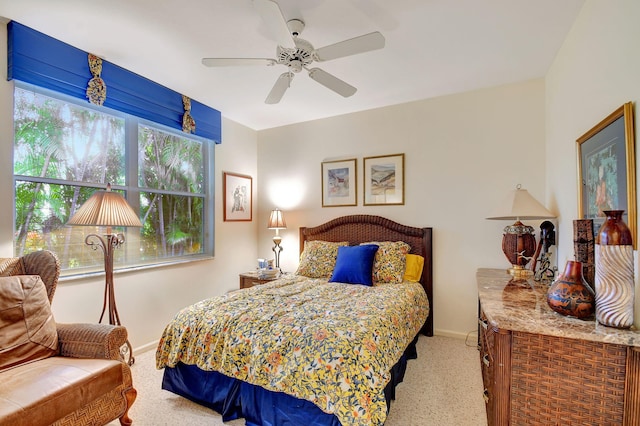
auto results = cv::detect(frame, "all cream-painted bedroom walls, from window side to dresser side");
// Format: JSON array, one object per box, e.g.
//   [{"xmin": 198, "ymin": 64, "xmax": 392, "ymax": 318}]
[{"xmin": 6, "ymin": 0, "xmax": 640, "ymax": 347}]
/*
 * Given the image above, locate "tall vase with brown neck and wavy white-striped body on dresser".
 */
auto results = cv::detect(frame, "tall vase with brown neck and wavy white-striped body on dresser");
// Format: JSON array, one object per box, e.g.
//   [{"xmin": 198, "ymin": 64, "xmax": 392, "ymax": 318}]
[{"xmin": 595, "ymin": 210, "xmax": 634, "ymax": 328}]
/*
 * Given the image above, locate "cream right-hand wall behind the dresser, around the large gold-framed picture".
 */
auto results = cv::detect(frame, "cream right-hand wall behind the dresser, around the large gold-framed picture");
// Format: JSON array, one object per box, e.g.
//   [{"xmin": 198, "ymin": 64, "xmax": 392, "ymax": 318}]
[{"xmin": 545, "ymin": 0, "xmax": 640, "ymax": 326}]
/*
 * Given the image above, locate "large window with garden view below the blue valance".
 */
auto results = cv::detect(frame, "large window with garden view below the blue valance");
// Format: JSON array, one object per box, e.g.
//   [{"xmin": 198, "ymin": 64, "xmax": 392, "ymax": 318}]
[{"xmin": 13, "ymin": 85, "xmax": 214, "ymax": 275}]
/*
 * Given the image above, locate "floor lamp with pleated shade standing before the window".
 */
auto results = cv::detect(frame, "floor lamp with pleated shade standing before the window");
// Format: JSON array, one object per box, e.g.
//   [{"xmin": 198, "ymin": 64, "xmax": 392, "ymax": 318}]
[{"xmin": 67, "ymin": 184, "xmax": 142, "ymax": 365}]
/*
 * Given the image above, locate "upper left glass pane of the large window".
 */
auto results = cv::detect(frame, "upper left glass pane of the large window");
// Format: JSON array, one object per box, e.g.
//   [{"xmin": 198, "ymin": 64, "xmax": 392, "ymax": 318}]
[{"xmin": 14, "ymin": 88, "xmax": 125, "ymax": 185}]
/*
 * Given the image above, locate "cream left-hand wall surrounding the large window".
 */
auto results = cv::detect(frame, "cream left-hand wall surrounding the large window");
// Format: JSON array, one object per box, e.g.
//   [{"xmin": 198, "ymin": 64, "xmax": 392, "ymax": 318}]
[{"xmin": 0, "ymin": 26, "xmax": 257, "ymax": 350}]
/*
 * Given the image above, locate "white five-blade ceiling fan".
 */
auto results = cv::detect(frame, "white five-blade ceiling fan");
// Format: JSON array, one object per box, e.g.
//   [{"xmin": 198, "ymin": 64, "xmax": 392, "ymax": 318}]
[{"xmin": 202, "ymin": 0, "xmax": 385, "ymax": 104}]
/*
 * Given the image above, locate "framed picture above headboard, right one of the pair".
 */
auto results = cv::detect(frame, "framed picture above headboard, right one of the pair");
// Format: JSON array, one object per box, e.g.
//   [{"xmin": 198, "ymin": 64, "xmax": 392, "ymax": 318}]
[{"xmin": 363, "ymin": 154, "xmax": 404, "ymax": 206}]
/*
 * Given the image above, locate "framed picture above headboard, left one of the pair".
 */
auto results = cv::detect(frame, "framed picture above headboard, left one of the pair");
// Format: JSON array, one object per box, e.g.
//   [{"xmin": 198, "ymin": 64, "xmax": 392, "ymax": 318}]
[{"xmin": 322, "ymin": 158, "xmax": 358, "ymax": 207}]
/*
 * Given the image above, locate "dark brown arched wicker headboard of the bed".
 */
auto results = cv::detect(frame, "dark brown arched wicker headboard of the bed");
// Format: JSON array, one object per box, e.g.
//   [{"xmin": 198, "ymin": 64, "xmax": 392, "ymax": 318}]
[{"xmin": 300, "ymin": 215, "xmax": 433, "ymax": 336}]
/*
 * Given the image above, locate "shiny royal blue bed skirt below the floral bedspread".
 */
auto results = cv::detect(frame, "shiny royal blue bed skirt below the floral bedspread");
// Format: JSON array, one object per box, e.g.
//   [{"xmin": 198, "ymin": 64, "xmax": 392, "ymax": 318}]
[{"xmin": 162, "ymin": 336, "xmax": 418, "ymax": 426}]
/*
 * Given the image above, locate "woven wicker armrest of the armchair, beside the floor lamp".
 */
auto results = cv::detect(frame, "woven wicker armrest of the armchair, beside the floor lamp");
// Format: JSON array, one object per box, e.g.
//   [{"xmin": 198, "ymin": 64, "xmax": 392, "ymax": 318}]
[{"xmin": 56, "ymin": 324, "xmax": 127, "ymax": 361}]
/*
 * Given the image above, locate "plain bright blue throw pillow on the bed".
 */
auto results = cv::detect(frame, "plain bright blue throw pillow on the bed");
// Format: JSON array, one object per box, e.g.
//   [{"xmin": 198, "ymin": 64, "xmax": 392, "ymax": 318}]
[{"xmin": 329, "ymin": 244, "xmax": 378, "ymax": 287}]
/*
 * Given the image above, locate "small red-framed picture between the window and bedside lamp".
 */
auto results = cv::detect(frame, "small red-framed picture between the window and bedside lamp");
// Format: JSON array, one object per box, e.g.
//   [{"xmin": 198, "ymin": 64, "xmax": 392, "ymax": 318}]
[{"xmin": 222, "ymin": 172, "xmax": 253, "ymax": 222}]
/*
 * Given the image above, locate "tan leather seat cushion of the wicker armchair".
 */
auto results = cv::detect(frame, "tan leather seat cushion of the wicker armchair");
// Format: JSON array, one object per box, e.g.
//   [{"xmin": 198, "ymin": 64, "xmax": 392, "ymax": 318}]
[{"xmin": 0, "ymin": 356, "xmax": 125, "ymax": 426}]
